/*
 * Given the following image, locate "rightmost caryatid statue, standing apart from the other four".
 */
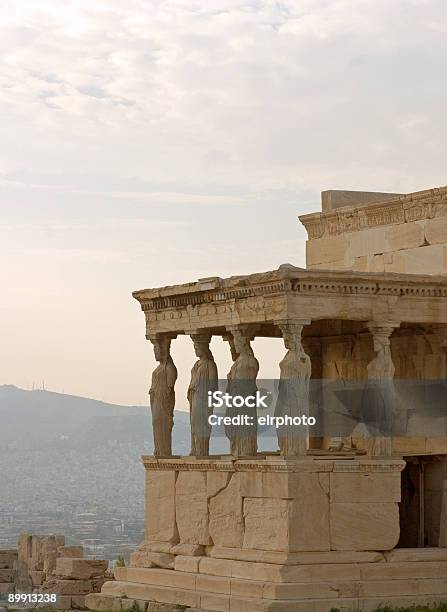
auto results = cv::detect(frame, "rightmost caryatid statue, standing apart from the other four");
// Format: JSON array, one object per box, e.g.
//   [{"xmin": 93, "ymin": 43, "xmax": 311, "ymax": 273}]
[{"xmin": 362, "ymin": 321, "xmax": 400, "ymax": 457}]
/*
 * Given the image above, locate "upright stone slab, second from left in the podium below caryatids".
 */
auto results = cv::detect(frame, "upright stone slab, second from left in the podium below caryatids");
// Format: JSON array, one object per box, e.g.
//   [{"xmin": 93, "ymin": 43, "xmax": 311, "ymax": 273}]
[{"xmin": 175, "ymin": 472, "xmax": 211, "ymax": 545}]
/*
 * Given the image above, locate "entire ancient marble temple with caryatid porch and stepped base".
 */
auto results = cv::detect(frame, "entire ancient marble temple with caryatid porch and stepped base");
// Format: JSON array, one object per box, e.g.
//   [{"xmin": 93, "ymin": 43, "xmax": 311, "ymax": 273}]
[{"xmin": 87, "ymin": 188, "xmax": 447, "ymax": 612}]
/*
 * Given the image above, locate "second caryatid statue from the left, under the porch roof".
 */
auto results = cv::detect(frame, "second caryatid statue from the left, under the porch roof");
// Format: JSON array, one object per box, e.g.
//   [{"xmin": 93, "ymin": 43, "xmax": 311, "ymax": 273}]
[{"xmin": 188, "ymin": 334, "xmax": 218, "ymax": 457}]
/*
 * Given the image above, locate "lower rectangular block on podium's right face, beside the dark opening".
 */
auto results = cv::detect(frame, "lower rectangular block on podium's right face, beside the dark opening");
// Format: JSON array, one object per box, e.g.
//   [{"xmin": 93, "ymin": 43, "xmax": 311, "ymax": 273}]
[{"xmin": 330, "ymin": 502, "xmax": 400, "ymax": 551}]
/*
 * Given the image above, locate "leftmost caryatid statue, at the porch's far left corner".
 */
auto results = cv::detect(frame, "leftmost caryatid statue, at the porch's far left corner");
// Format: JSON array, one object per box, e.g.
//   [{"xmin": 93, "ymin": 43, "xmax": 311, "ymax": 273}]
[{"xmin": 149, "ymin": 336, "xmax": 177, "ymax": 457}]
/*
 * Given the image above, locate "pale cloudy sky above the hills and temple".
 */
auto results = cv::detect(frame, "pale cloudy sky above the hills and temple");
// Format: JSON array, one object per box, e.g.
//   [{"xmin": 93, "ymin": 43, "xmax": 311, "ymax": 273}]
[{"xmin": 0, "ymin": 0, "xmax": 447, "ymax": 409}]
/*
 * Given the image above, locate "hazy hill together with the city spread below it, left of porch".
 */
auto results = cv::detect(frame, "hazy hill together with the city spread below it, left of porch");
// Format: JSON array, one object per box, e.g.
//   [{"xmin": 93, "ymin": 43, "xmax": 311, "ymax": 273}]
[{"xmin": 0, "ymin": 385, "xmax": 195, "ymax": 558}]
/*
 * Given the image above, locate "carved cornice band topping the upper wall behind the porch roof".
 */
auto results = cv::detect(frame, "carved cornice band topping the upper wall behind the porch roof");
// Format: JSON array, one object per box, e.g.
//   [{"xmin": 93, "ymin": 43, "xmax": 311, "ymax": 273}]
[{"xmin": 298, "ymin": 187, "xmax": 447, "ymax": 240}]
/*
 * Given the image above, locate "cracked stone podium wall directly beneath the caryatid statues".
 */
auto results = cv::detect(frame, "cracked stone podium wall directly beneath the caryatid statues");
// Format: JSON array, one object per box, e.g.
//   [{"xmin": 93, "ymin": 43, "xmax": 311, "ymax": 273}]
[{"xmin": 131, "ymin": 456, "xmax": 404, "ymax": 568}]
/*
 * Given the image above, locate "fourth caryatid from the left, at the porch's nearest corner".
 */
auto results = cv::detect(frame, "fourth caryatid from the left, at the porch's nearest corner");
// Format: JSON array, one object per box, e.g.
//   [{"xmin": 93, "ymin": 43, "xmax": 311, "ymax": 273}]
[{"xmin": 275, "ymin": 323, "xmax": 311, "ymax": 457}]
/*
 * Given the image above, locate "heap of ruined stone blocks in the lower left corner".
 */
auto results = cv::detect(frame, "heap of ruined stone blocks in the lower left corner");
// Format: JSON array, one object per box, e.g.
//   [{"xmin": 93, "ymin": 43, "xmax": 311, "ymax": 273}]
[{"xmin": 0, "ymin": 534, "xmax": 112, "ymax": 609}]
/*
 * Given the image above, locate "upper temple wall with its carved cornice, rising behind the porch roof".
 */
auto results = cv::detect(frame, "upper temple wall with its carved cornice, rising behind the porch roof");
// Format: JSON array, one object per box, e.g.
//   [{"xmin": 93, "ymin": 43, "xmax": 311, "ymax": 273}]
[{"xmin": 300, "ymin": 188, "xmax": 447, "ymax": 274}]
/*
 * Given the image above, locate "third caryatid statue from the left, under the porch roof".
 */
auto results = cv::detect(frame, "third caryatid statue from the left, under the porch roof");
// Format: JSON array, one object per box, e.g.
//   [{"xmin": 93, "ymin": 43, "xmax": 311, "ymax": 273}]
[{"xmin": 225, "ymin": 326, "xmax": 259, "ymax": 457}]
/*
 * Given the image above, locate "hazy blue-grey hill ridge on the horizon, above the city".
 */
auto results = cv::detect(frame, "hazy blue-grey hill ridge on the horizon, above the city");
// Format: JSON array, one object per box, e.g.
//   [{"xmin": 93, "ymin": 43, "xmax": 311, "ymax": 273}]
[{"xmin": 0, "ymin": 385, "xmax": 189, "ymax": 454}]
